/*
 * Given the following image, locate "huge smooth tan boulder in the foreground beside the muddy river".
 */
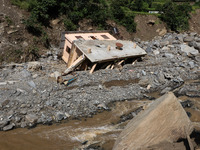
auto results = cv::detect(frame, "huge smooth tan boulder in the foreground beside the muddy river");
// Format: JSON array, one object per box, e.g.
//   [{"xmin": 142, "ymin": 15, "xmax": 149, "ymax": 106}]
[{"xmin": 113, "ymin": 93, "xmax": 193, "ymax": 150}]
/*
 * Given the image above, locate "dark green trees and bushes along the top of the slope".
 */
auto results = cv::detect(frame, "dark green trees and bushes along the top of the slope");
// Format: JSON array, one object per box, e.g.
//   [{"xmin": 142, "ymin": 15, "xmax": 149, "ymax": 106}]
[{"xmin": 11, "ymin": 0, "xmax": 200, "ymax": 34}]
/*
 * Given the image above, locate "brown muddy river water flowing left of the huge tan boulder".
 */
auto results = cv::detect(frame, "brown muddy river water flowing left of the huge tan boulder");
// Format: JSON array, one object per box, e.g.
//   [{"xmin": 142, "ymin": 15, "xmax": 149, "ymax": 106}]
[{"xmin": 0, "ymin": 100, "xmax": 149, "ymax": 150}]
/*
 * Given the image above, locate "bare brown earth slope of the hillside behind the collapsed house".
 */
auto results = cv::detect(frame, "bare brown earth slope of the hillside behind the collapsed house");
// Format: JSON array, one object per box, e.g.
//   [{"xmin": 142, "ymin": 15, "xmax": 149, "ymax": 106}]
[{"xmin": 0, "ymin": 0, "xmax": 200, "ymax": 63}]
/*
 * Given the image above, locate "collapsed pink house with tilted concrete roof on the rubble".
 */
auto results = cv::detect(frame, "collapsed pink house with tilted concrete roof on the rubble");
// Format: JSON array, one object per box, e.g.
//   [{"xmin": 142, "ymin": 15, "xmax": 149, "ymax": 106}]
[{"xmin": 60, "ymin": 31, "xmax": 146, "ymax": 74}]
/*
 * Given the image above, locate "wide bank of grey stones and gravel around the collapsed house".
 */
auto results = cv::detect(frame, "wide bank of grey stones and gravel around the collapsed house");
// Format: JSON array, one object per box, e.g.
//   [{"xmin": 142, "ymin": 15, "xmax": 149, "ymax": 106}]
[{"xmin": 0, "ymin": 33, "xmax": 200, "ymax": 130}]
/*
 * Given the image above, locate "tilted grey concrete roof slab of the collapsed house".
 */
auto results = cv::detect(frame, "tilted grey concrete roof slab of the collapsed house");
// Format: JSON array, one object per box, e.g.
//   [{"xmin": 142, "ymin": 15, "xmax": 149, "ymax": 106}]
[{"xmin": 74, "ymin": 40, "xmax": 146, "ymax": 63}]
